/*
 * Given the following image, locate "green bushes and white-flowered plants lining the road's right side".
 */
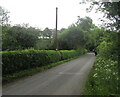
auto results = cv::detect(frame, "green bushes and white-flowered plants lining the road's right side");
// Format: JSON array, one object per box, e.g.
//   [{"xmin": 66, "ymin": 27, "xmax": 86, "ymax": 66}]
[{"xmin": 85, "ymin": 31, "xmax": 120, "ymax": 95}]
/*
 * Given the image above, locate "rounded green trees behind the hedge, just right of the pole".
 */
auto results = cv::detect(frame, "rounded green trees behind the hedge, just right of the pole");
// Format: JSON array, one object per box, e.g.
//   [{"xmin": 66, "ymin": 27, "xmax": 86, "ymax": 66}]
[{"xmin": 59, "ymin": 17, "xmax": 101, "ymax": 51}]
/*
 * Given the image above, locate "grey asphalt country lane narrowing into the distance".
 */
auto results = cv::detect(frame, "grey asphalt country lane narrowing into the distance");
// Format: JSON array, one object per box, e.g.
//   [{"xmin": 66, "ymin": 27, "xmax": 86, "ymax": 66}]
[{"xmin": 2, "ymin": 53, "xmax": 95, "ymax": 95}]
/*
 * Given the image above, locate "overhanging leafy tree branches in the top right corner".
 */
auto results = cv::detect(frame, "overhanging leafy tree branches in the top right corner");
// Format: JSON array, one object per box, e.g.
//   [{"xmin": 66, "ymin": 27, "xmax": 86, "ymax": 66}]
[{"xmin": 87, "ymin": 2, "xmax": 120, "ymax": 32}]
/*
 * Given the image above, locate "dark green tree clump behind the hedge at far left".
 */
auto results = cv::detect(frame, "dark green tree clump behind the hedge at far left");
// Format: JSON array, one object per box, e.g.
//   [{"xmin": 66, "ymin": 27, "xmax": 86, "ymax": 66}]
[{"xmin": 2, "ymin": 26, "xmax": 40, "ymax": 50}]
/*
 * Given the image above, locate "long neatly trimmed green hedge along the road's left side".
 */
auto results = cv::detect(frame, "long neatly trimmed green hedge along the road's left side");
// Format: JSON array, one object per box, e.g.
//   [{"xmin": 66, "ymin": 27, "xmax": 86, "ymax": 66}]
[{"xmin": 2, "ymin": 49, "xmax": 86, "ymax": 76}]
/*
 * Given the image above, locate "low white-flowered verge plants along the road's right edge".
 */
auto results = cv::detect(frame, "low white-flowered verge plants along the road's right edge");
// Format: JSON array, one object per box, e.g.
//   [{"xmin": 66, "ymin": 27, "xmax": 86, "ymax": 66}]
[{"xmin": 83, "ymin": 56, "xmax": 120, "ymax": 97}]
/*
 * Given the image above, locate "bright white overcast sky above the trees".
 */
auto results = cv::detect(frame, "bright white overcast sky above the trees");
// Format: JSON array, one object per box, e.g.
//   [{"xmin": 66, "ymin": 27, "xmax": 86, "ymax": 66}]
[{"xmin": 0, "ymin": 0, "xmax": 102, "ymax": 29}]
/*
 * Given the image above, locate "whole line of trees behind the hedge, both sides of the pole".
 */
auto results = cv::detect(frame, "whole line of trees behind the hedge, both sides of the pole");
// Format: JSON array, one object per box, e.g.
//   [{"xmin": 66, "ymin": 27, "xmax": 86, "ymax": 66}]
[{"xmin": 0, "ymin": 5, "xmax": 102, "ymax": 51}]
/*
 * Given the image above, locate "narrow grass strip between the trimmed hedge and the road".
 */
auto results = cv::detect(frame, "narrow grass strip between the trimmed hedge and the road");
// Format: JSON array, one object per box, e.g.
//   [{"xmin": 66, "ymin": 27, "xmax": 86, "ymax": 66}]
[{"xmin": 2, "ymin": 55, "xmax": 82, "ymax": 85}]
